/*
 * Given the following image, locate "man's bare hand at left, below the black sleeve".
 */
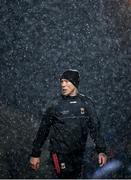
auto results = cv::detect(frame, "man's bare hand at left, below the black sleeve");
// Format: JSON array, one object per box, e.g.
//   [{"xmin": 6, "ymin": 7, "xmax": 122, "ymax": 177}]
[{"xmin": 30, "ymin": 157, "xmax": 40, "ymax": 171}]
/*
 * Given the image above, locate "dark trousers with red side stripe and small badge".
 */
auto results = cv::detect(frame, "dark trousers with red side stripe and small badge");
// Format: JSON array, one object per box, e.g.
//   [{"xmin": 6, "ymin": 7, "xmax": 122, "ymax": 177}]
[{"xmin": 51, "ymin": 151, "xmax": 83, "ymax": 179}]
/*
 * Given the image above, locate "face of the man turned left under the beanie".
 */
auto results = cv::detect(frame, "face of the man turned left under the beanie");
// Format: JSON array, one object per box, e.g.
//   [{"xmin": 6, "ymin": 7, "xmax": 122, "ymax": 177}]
[{"xmin": 60, "ymin": 79, "xmax": 76, "ymax": 96}]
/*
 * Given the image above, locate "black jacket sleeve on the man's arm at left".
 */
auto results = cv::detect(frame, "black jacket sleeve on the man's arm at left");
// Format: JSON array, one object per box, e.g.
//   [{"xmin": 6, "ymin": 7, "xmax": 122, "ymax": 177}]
[{"xmin": 31, "ymin": 108, "xmax": 53, "ymax": 157}]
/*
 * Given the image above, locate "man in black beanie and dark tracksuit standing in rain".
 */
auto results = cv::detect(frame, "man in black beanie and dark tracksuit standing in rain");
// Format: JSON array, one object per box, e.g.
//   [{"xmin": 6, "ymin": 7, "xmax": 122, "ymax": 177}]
[{"xmin": 30, "ymin": 70, "xmax": 107, "ymax": 178}]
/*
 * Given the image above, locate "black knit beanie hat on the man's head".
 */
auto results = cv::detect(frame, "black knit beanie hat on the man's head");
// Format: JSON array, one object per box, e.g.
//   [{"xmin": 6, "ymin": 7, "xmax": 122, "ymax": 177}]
[{"xmin": 60, "ymin": 69, "xmax": 80, "ymax": 88}]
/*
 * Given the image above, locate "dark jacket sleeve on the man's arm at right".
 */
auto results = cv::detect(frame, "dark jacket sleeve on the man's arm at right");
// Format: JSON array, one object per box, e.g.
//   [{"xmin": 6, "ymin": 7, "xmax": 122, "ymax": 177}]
[{"xmin": 86, "ymin": 97, "xmax": 106, "ymax": 153}]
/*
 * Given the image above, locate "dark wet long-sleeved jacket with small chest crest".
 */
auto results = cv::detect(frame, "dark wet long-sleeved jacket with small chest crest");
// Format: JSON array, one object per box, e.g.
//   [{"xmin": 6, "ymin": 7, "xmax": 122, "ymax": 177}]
[{"xmin": 31, "ymin": 94, "xmax": 105, "ymax": 157}]
